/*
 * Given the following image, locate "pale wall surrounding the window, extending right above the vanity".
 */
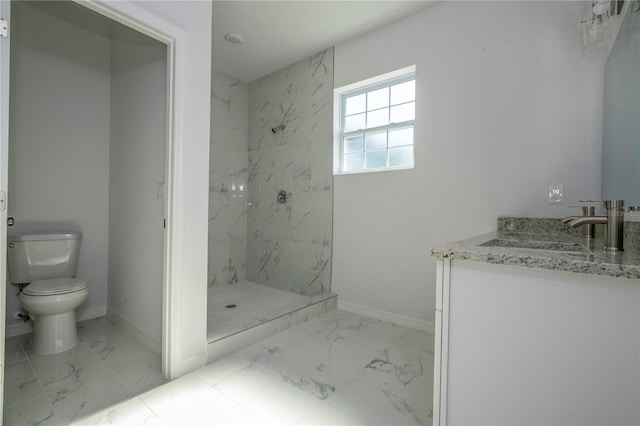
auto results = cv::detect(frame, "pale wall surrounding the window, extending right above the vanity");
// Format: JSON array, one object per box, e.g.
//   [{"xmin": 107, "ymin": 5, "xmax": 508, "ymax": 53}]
[{"xmin": 332, "ymin": 1, "xmax": 605, "ymax": 322}]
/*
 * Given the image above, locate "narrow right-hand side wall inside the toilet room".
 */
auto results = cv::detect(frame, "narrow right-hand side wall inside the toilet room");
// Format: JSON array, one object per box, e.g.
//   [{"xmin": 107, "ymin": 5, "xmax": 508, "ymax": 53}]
[{"xmin": 107, "ymin": 24, "xmax": 167, "ymax": 350}]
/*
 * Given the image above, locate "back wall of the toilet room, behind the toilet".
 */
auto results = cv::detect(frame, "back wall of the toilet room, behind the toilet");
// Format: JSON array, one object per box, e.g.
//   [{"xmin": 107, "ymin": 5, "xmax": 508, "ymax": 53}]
[{"xmin": 7, "ymin": 2, "xmax": 110, "ymax": 326}]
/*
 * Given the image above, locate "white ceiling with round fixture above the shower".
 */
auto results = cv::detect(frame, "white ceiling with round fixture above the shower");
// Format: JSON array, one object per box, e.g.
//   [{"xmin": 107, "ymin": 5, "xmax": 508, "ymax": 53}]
[{"xmin": 212, "ymin": 0, "xmax": 433, "ymax": 83}]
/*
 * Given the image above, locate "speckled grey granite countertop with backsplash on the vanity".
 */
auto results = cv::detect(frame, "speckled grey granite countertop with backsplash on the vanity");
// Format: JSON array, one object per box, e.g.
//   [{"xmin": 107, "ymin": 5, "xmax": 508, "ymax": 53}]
[{"xmin": 431, "ymin": 217, "xmax": 640, "ymax": 279}]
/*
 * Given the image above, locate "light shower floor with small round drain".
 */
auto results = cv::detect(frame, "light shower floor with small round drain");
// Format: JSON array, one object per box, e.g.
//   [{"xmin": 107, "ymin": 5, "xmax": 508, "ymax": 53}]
[{"xmin": 207, "ymin": 281, "xmax": 333, "ymax": 342}]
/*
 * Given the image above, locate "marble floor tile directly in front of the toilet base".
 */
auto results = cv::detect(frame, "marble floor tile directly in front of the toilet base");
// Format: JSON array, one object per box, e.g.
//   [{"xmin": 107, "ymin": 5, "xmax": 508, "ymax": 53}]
[{"xmin": 29, "ymin": 344, "xmax": 110, "ymax": 394}]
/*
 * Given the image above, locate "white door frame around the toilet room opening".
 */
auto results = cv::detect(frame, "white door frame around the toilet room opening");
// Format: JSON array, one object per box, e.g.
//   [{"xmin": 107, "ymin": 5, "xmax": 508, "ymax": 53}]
[{"xmin": 0, "ymin": 0, "xmax": 211, "ymax": 390}]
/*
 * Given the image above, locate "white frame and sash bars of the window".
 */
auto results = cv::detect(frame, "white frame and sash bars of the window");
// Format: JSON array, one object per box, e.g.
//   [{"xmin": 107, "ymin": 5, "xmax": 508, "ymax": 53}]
[{"xmin": 333, "ymin": 65, "xmax": 416, "ymax": 175}]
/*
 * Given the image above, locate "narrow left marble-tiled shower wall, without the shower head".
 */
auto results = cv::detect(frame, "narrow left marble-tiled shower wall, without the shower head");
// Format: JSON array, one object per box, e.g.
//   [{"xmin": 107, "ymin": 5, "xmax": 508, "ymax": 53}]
[{"xmin": 208, "ymin": 70, "xmax": 249, "ymax": 289}]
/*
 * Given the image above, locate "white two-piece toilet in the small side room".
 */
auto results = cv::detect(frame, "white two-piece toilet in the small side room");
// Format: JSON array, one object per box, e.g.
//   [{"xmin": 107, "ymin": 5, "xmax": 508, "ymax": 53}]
[{"xmin": 7, "ymin": 232, "xmax": 89, "ymax": 355}]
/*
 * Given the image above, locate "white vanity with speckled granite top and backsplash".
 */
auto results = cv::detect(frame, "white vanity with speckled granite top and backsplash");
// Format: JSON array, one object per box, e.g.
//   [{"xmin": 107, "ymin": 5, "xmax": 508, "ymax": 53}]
[{"xmin": 431, "ymin": 217, "xmax": 640, "ymax": 425}]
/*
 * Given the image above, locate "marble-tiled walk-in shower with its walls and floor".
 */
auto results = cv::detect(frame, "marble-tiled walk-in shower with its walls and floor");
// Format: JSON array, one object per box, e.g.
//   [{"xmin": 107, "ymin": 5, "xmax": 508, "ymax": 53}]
[{"xmin": 207, "ymin": 49, "xmax": 335, "ymax": 358}]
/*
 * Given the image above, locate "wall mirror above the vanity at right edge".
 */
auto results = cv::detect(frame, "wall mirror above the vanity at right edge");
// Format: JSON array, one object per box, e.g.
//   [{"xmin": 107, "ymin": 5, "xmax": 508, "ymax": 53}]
[{"xmin": 602, "ymin": 2, "xmax": 640, "ymax": 206}]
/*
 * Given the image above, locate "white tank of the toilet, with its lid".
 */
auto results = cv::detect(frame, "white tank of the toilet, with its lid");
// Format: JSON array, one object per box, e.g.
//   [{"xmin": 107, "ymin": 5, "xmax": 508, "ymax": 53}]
[{"xmin": 7, "ymin": 232, "xmax": 82, "ymax": 284}]
